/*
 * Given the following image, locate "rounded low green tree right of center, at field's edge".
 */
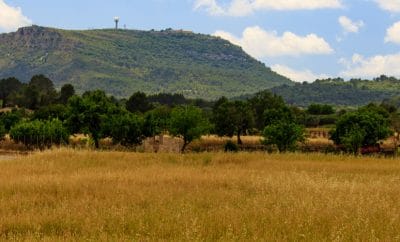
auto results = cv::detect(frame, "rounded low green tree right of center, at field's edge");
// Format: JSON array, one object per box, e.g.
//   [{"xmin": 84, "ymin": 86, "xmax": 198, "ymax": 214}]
[{"xmin": 262, "ymin": 120, "xmax": 304, "ymax": 152}]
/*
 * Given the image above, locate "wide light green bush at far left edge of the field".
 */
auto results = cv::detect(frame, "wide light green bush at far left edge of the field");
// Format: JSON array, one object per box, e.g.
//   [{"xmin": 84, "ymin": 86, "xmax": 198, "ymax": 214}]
[{"xmin": 10, "ymin": 119, "xmax": 69, "ymax": 149}]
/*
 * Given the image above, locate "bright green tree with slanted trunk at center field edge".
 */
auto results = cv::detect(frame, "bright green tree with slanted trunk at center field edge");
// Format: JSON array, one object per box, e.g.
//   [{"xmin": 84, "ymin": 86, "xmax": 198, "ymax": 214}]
[{"xmin": 169, "ymin": 106, "xmax": 210, "ymax": 153}]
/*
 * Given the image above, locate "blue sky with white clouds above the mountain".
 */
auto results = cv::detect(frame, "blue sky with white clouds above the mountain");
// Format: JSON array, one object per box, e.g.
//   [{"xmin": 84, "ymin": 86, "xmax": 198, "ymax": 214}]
[{"xmin": 0, "ymin": 0, "xmax": 400, "ymax": 81}]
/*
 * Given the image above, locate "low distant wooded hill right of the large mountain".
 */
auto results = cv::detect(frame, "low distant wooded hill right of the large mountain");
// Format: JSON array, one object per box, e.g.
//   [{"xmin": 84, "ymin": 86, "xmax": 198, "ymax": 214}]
[{"xmin": 270, "ymin": 75, "xmax": 400, "ymax": 107}]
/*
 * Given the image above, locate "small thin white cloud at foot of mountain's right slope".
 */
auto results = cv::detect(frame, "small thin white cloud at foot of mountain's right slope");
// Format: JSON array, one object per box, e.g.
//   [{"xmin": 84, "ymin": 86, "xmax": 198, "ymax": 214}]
[{"xmin": 271, "ymin": 65, "xmax": 329, "ymax": 82}]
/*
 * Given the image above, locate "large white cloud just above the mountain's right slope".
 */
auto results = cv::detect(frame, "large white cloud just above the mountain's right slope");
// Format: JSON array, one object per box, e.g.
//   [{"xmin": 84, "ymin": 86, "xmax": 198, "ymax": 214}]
[{"xmin": 214, "ymin": 26, "xmax": 333, "ymax": 59}]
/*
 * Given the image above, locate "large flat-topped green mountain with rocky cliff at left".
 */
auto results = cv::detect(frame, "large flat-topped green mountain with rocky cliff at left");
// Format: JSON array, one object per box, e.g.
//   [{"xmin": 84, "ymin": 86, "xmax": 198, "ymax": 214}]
[{"xmin": 0, "ymin": 26, "xmax": 291, "ymax": 99}]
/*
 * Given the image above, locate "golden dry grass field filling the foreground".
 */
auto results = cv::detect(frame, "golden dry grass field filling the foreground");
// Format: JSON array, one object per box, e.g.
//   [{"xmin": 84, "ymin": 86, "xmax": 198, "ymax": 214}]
[{"xmin": 0, "ymin": 150, "xmax": 400, "ymax": 241}]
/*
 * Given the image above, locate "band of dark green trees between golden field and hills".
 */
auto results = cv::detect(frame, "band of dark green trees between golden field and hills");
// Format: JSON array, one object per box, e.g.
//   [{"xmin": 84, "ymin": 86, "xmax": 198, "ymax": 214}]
[{"xmin": 0, "ymin": 75, "xmax": 400, "ymax": 153}]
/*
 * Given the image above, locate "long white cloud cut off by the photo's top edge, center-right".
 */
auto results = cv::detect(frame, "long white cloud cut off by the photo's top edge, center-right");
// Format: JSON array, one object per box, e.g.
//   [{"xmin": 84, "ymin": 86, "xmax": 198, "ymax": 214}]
[{"xmin": 194, "ymin": 0, "xmax": 342, "ymax": 16}]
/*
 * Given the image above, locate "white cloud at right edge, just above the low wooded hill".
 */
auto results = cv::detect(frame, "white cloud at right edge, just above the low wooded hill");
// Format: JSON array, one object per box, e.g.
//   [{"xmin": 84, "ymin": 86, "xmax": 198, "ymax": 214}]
[{"xmin": 339, "ymin": 53, "xmax": 400, "ymax": 78}]
